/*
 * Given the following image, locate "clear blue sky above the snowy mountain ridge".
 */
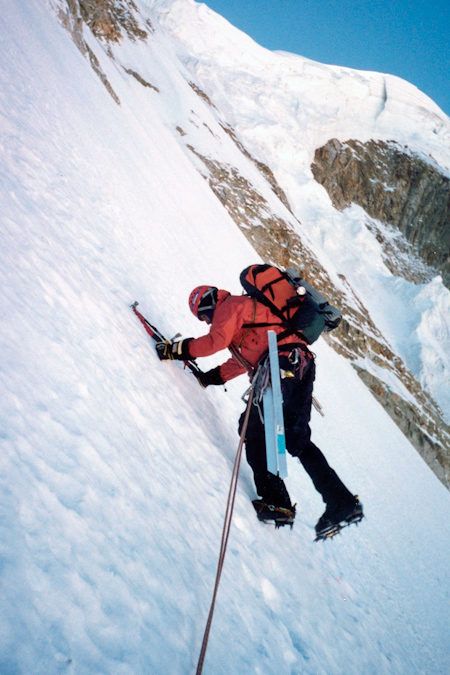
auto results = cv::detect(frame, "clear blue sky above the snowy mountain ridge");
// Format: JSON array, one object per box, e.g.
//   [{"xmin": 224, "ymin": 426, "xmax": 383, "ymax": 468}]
[{"xmin": 205, "ymin": 0, "xmax": 450, "ymax": 115}]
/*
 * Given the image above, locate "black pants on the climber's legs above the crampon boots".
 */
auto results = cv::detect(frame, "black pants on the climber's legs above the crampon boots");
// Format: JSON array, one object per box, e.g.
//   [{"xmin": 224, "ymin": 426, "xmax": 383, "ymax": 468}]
[{"xmin": 239, "ymin": 352, "xmax": 352, "ymax": 507}]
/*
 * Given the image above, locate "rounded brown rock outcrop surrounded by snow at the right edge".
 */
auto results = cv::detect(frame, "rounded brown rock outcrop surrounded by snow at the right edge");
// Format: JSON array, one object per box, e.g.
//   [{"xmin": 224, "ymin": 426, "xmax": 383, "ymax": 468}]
[{"xmin": 311, "ymin": 139, "xmax": 450, "ymax": 288}]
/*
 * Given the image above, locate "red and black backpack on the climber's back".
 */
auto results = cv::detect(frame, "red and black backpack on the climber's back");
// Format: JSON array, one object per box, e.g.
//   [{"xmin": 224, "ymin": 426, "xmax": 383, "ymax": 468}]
[{"xmin": 240, "ymin": 265, "xmax": 342, "ymax": 344}]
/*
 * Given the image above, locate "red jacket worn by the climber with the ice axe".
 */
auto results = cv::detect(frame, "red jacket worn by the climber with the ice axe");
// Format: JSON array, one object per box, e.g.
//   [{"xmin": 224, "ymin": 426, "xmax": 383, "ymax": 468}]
[{"xmin": 189, "ymin": 290, "xmax": 306, "ymax": 382}]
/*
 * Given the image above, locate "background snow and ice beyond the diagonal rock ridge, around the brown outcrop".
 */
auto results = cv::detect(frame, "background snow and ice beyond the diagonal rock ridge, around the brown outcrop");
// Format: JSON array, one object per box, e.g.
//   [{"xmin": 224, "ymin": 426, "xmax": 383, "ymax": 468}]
[{"xmin": 150, "ymin": 0, "xmax": 450, "ymax": 422}]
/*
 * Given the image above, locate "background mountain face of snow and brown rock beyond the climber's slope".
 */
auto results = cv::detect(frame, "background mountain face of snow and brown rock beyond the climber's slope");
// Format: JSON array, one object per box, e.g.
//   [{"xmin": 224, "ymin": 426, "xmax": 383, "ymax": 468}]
[{"xmin": 53, "ymin": 0, "xmax": 450, "ymax": 486}]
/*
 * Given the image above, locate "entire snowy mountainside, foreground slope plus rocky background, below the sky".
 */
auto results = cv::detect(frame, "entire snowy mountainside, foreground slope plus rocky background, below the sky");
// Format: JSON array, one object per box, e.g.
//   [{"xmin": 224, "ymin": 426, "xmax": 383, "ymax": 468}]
[{"xmin": 0, "ymin": 0, "xmax": 450, "ymax": 675}]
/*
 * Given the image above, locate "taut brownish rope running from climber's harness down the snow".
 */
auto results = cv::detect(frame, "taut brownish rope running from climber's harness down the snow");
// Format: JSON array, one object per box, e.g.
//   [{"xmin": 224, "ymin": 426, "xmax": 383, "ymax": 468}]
[{"xmin": 195, "ymin": 387, "xmax": 253, "ymax": 675}]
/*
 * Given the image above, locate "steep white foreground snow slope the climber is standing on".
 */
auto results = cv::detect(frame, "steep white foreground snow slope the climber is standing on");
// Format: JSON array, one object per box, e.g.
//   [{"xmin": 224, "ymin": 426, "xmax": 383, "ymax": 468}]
[{"xmin": 0, "ymin": 0, "xmax": 450, "ymax": 675}]
